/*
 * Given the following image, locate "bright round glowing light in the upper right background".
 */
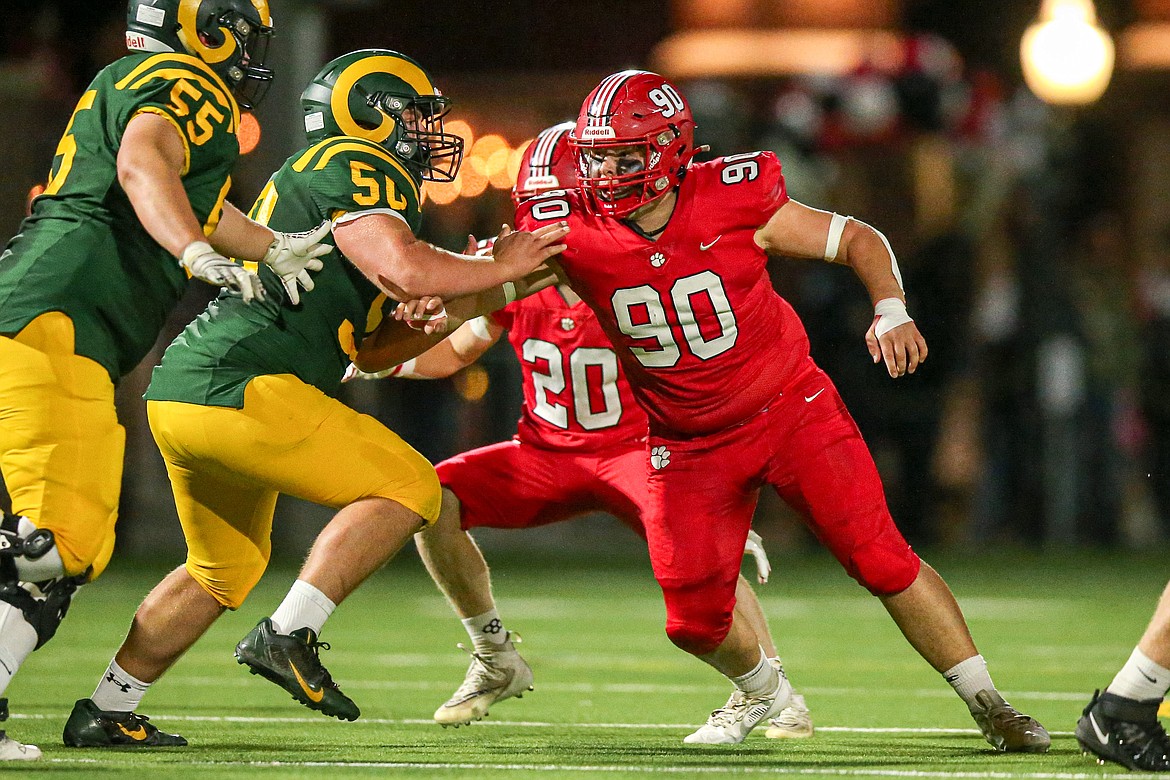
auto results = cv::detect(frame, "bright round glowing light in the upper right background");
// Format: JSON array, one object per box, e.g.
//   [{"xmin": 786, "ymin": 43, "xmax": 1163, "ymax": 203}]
[{"xmin": 1020, "ymin": 0, "xmax": 1114, "ymax": 105}]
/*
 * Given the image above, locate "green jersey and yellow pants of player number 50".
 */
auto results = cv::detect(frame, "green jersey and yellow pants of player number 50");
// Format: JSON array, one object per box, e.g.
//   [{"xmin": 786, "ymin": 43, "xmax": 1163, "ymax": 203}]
[{"xmin": 146, "ymin": 136, "xmax": 440, "ymax": 607}]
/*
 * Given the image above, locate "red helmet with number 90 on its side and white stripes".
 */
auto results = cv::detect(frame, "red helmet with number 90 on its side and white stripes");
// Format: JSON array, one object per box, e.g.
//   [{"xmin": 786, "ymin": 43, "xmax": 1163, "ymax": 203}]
[{"xmin": 569, "ymin": 70, "xmax": 695, "ymax": 216}]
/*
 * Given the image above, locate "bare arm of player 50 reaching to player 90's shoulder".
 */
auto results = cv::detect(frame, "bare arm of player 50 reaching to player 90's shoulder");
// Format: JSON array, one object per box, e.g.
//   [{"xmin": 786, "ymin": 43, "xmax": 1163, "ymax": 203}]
[{"xmin": 333, "ymin": 214, "xmax": 569, "ymax": 301}]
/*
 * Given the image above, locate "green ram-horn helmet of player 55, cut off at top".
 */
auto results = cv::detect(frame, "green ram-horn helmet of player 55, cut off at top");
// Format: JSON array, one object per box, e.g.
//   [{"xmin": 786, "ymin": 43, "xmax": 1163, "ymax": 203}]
[{"xmin": 126, "ymin": 0, "xmax": 273, "ymax": 109}]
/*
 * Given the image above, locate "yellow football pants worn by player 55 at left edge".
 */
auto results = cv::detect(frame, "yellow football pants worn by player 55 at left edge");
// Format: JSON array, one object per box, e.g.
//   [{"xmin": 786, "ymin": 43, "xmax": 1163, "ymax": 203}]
[{"xmin": 0, "ymin": 312, "xmax": 126, "ymax": 579}]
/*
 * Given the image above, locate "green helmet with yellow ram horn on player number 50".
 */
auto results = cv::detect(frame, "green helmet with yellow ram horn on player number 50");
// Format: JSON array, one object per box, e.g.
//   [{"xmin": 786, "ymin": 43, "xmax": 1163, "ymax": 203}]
[{"xmin": 301, "ymin": 49, "xmax": 463, "ymax": 181}]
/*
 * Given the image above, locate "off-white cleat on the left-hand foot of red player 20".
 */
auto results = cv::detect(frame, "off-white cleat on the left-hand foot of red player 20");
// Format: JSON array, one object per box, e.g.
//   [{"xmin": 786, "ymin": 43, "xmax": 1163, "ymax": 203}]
[{"xmin": 434, "ymin": 631, "xmax": 532, "ymax": 729}]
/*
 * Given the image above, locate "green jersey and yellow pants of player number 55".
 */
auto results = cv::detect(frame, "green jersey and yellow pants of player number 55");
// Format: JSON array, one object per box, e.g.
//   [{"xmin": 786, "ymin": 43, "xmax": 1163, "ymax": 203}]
[{"xmin": 0, "ymin": 53, "xmax": 240, "ymax": 577}]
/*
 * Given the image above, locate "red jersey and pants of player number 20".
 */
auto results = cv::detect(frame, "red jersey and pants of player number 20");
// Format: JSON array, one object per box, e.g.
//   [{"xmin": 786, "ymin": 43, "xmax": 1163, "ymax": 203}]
[{"xmin": 436, "ymin": 287, "xmax": 647, "ymax": 536}]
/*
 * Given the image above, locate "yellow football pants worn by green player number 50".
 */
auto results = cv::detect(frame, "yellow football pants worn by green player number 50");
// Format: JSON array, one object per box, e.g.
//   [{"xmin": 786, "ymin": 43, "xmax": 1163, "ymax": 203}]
[{"xmin": 146, "ymin": 374, "xmax": 440, "ymax": 609}]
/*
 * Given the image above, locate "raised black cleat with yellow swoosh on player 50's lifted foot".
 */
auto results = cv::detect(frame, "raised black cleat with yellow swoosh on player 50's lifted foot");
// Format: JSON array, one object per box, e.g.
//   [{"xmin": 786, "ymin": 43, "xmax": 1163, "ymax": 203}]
[{"xmin": 235, "ymin": 617, "xmax": 362, "ymax": 720}]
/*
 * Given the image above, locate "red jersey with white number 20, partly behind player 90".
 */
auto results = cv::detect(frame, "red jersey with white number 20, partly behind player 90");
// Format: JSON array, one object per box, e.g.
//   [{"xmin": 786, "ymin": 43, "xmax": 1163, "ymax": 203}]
[{"xmin": 491, "ymin": 287, "xmax": 648, "ymax": 451}]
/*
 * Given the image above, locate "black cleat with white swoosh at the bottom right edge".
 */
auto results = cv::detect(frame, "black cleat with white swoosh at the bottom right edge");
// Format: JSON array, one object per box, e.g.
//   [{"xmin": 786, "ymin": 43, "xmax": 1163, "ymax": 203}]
[{"xmin": 1076, "ymin": 691, "xmax": 1170, "ymax": 772}]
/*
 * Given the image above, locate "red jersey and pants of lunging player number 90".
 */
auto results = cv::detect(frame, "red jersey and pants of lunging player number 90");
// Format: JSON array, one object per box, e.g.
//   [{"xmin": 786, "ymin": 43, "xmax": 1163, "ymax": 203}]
[{"xmin": 516, "ymin": 152, "xmax": 920, "ymax": 655}]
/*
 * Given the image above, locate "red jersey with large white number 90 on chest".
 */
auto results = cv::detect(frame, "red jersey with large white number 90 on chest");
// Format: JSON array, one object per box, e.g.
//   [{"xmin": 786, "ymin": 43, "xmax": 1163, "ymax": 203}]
[{"xmin": 516, "ymin": 152, "xmax": 814, "ymax": 435}]
